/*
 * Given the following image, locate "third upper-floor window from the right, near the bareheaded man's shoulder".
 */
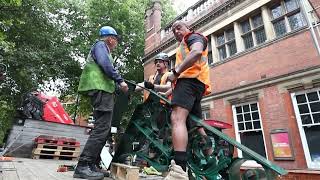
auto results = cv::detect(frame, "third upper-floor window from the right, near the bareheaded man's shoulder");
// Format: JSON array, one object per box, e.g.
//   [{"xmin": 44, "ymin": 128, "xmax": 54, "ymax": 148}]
[{"xmin": 217, "ymin": 29, "xmax": 237, "ymax": 60}]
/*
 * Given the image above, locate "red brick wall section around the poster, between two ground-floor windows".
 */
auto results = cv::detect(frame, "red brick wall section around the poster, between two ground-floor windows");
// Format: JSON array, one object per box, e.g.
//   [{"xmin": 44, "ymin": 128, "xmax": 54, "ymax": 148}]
[{"xmin": 259, "ymin": 86, "xmax": 307, "ymax": 169}]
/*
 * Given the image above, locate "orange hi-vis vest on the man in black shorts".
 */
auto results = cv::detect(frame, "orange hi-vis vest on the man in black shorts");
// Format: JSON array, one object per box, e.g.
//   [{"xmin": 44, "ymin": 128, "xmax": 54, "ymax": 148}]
[{"xmin": 175, "ymin": 32, "xmax": 211, "ymax": 95}]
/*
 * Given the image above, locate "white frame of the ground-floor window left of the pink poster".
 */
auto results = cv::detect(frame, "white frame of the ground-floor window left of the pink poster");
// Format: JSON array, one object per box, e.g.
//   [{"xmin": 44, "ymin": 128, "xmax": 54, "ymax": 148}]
[{"xmin": 232, "ymin": 101, "xmax": 269, "ymax": 161}]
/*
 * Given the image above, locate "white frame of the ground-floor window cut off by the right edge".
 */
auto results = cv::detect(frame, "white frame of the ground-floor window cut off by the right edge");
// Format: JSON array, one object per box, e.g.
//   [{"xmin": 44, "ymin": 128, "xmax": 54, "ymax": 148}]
[{"xmin": 290, "ymin": 88, "xmax": 320, "ymax": 170}]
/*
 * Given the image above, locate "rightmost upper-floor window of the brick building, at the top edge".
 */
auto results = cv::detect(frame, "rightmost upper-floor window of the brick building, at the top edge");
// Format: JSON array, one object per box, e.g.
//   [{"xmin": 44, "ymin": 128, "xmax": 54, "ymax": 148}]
[{"xmin": 271, "ymin": 0, "xmax": 306, "ymax": 37}]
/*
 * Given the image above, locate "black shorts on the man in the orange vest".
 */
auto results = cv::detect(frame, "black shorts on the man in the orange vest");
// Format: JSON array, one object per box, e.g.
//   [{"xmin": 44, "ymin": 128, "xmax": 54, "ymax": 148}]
[{"xmin": 171, "ymin": 78, "xmax": 205, "ymax": 119}]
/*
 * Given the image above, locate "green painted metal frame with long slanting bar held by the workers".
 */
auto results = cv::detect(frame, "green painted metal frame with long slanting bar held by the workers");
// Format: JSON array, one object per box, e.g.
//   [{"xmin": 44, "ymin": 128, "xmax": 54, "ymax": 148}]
[{"xmin": 115, "ymin": 80, "xmax": 287, "ymax": 180}]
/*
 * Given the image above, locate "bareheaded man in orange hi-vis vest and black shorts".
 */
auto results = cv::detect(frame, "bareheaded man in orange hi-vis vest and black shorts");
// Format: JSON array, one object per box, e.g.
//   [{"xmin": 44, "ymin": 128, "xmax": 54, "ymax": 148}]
[{"xmin": 165, "ymin": 21, "xmax": 211, "ymax": 180}]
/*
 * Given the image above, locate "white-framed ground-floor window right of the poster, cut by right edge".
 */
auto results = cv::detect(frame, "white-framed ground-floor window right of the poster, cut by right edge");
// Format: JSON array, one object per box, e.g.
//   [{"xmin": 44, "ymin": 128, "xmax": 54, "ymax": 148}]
[{"xmin": 292, "ymin": 89, "xmax": 320, "ymax": 168}]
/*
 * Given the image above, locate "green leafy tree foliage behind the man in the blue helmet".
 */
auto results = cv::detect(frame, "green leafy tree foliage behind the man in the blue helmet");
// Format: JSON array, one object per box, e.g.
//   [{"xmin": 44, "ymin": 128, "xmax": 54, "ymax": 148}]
[{"xmin": 0, "ymin": 0, "xmax": 174, "ymax": 142}]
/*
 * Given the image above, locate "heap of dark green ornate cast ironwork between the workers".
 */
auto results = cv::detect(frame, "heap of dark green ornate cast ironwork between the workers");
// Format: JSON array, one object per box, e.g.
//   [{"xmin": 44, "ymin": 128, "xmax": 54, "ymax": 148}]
[{"xmin": 114, "ymin": 81, "xmax": 287, "ymax": 180}]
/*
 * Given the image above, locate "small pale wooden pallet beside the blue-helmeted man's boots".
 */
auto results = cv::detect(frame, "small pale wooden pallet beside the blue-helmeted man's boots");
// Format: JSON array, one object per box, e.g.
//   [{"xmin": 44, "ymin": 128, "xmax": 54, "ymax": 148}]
[{"xmin": 111, "ymin": 163, "xmax": 140, "ymax": 180}]
